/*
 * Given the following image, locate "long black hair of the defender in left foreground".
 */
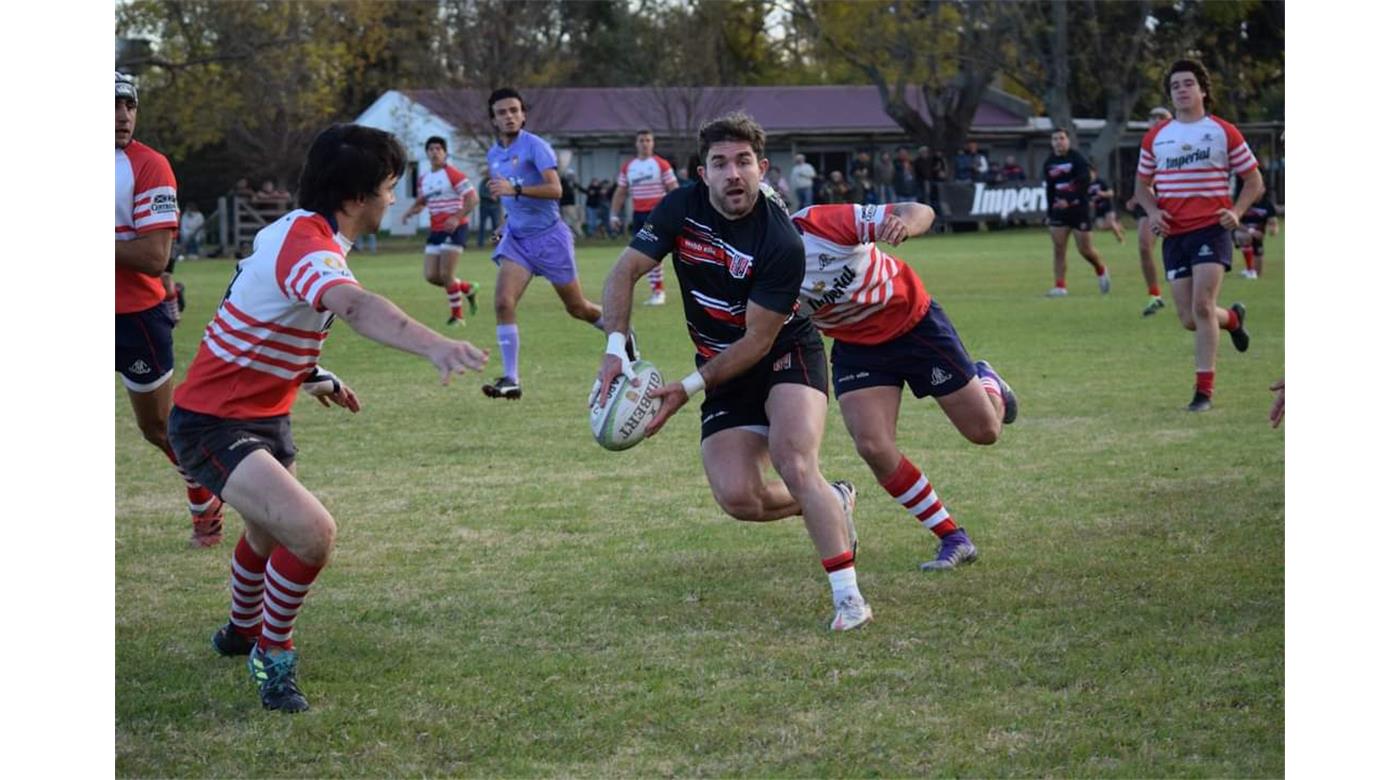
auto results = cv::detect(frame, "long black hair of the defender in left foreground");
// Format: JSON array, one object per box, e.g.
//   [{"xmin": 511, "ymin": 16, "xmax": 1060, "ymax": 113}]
[{"xmin": 297, "ymin": 125, "xmax": 407, "ymax": 217}]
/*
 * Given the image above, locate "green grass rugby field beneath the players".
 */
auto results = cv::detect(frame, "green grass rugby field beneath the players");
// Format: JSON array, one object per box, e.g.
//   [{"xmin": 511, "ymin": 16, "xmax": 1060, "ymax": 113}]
[{"xmin": 113, "ymin": 222, "xmax": 1285, "ymax": 777}]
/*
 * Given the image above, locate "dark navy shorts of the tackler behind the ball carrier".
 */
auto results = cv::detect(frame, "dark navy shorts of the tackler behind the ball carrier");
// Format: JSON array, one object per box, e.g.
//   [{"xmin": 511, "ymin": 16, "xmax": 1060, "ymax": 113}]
[{"xmin": 832, "ymin": 301, "xmax": 977, "ymax": 398}]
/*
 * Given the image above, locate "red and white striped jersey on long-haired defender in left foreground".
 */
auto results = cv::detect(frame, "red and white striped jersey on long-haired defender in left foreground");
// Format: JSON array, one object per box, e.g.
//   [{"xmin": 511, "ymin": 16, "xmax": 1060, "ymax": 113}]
[{"xmin": 175, "ymin": 209, "xmax": 358, "ymax": 420}]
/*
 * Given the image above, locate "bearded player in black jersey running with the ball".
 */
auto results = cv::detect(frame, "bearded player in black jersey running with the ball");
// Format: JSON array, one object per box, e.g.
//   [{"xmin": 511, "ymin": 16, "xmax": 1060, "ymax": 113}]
[{"xmin": 598, "ymin": 113, "xmax": 871, "ymax": 632}]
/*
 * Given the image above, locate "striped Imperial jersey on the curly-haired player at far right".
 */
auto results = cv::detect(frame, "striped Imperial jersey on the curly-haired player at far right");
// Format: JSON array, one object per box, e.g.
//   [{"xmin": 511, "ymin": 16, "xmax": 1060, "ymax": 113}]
[{"xmin": 1138, "ymin": 113, "xmax": 1259, "ymax": 235}]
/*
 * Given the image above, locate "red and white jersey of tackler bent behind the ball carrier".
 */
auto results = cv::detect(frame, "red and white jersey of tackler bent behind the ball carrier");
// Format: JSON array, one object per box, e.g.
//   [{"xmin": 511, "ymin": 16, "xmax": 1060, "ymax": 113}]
[{"xmin": 792, "ymin": 203, "xmax": 930, "ymax": 344}]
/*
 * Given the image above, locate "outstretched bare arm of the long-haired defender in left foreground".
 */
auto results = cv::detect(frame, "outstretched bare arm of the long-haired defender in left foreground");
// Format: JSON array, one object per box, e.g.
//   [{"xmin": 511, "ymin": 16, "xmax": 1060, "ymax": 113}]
[{"xmin": 321, "ymin": 284, "xmax": 490, "ymax": 385}]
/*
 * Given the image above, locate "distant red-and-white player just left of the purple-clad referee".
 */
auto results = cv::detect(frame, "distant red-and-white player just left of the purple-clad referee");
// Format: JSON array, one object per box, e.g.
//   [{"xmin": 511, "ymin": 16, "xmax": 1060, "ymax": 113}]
[{"xmin": 403, "ymin": 136, "xmax": 480, "ymax": 325}]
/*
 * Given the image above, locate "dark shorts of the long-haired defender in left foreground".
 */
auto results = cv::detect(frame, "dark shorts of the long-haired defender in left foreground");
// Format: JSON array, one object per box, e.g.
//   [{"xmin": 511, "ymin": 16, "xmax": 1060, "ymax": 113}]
[{"xmin": 168, "ymin": 406, "xmax": 297, "ymax": 499}]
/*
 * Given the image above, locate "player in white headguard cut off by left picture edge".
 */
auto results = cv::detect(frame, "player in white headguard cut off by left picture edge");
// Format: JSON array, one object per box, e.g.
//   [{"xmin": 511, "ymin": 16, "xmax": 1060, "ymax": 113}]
[{"xmin": 116, "ymin": 73, "xmax": 224, "ymax": 548}]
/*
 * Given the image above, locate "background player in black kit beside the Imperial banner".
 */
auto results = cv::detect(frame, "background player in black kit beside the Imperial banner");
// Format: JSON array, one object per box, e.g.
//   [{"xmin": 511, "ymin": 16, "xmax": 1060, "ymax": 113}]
[{"xmin": 1042, "ymin": 127, "xmax": 1109, "ymax": 298}]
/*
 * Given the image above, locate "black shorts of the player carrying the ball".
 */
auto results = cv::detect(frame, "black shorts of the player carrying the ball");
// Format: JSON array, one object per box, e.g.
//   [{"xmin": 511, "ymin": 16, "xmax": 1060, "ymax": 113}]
[{"xmin": 697, "ymin": 328, "xmax": 830, "ymax": 441}]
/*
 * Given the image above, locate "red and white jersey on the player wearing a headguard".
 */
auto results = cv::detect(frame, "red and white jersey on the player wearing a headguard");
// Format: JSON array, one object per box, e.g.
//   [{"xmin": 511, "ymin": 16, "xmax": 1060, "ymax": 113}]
[{"xmin": 116, "ymin": 140, "xmax": 179, "ymax": 314}]
